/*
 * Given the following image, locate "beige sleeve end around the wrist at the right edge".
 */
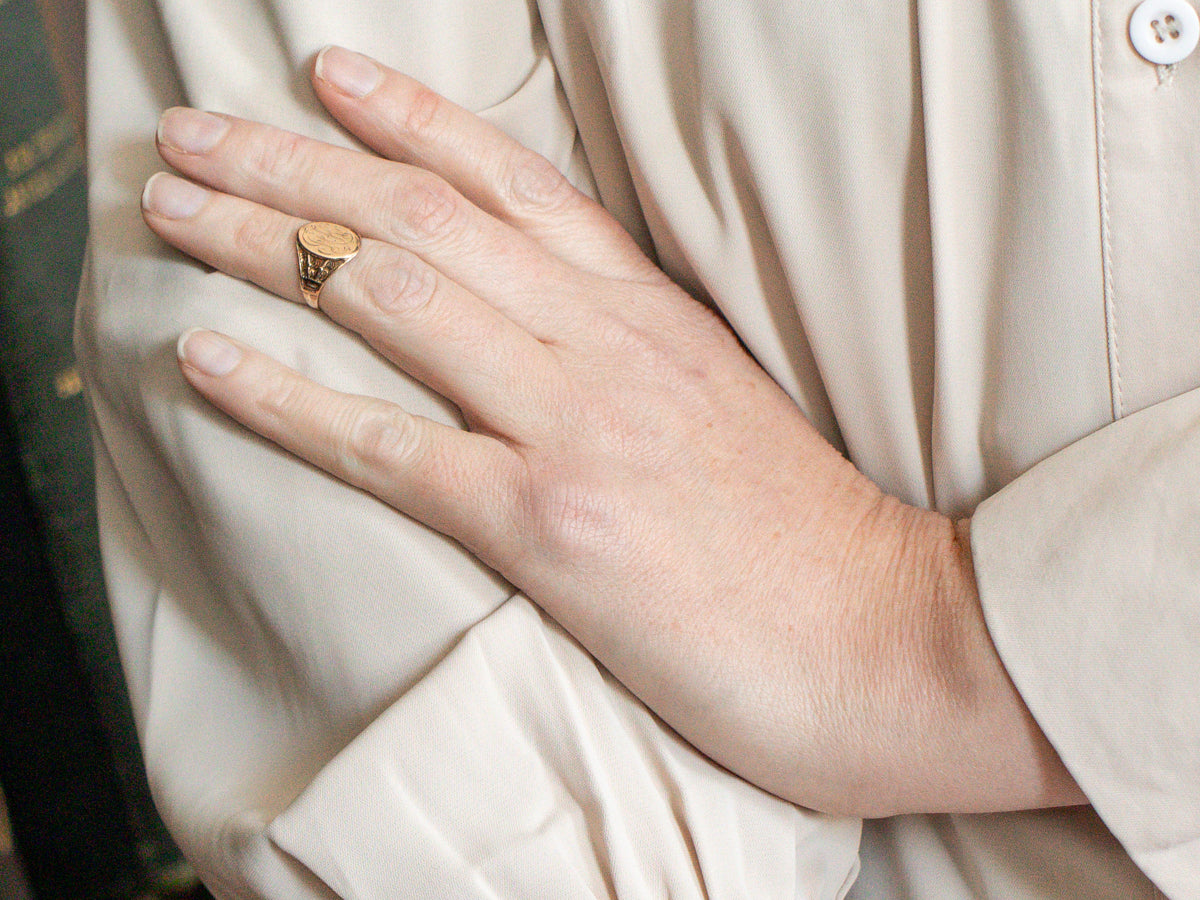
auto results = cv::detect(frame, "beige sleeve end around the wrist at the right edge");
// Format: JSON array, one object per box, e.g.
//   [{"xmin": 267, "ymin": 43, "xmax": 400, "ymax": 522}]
[{"xmin": 971, "ymin": 390, "xmax": 1200, "ymax": 898}]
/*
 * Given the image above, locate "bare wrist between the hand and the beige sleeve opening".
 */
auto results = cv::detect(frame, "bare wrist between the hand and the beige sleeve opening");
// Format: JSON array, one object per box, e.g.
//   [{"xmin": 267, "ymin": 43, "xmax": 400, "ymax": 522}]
[{"xmin": 827, "ymin": 508, "xmax": 1084, "ymax": 816}]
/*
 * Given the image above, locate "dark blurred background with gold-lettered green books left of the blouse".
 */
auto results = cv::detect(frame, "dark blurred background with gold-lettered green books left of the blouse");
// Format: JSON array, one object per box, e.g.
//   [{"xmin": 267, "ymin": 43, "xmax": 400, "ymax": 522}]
[{"xmin": 0, "ymin": 0, "xmax": 208, "ymax": 900}]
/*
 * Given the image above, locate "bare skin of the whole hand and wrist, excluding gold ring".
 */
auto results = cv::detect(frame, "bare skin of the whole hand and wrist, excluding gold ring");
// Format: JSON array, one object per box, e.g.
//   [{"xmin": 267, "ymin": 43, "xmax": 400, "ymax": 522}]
[{"xmin": 144, "ymin": 48, "xmax": 1084, "ymax": 816}]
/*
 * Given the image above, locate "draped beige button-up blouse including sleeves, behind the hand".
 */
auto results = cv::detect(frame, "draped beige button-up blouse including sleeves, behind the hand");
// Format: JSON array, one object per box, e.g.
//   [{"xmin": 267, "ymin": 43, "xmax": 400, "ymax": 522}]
[{"xmin": 79, "ymin": 0, "xmax": 1200, "ymax": 900}]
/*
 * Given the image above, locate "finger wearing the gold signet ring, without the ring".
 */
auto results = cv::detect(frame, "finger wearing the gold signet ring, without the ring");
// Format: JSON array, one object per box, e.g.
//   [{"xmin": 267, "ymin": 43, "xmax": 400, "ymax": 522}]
[{"xmin": 143, "ymin": 173, "xmax": 557, "ymax": 440}]
